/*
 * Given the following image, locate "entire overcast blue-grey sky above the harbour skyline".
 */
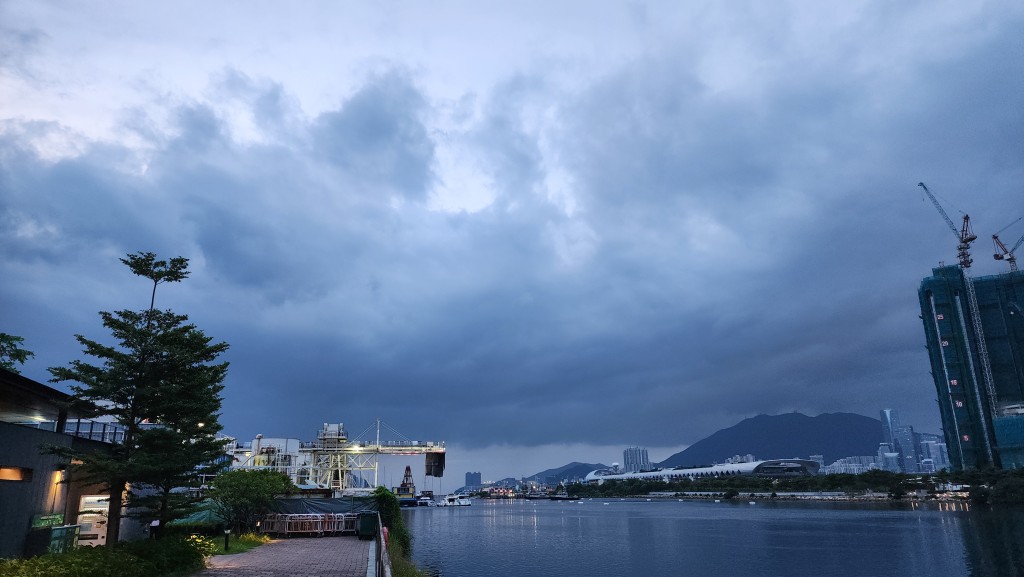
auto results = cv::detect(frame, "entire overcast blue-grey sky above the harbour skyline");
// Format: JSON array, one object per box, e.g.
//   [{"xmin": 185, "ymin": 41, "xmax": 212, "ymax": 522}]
[{"xmin": 0, "ymin": 0, "xmax": 1024, "ymax": 487}]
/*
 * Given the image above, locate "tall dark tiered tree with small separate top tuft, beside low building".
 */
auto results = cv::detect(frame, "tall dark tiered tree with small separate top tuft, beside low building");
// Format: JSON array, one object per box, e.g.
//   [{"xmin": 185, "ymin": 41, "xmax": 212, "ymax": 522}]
[{"xmin": 49, "ymin": 252, "xmax": 227, "ymax": 544}]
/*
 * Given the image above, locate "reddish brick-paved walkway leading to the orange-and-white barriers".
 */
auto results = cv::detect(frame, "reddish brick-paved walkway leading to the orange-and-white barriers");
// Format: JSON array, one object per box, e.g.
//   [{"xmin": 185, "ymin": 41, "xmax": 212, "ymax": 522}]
[{"xmin": 194, "ymin": 537, "xmax": 374, "ymax": 577}]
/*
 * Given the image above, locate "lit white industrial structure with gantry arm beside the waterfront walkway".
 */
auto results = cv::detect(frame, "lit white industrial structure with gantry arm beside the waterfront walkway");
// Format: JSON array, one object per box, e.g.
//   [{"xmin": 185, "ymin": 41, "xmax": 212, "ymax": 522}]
[{"xmin": 227, "ymin": 419, "xmax": 445, "ymax": 497}]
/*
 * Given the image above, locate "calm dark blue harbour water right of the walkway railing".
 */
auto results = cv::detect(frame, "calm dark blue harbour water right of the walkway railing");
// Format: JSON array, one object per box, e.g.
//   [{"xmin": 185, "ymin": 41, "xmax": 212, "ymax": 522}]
[{"xmin": 406, "ymin": 499, "xmax": 1024, "ymax": 577}]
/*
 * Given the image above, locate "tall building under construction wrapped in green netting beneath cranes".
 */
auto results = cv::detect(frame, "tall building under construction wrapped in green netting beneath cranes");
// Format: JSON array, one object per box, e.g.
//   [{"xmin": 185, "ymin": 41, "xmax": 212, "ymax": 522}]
[{"xmin": 918, "ymin": 266, "xmax": 1024, "ymax": 469}]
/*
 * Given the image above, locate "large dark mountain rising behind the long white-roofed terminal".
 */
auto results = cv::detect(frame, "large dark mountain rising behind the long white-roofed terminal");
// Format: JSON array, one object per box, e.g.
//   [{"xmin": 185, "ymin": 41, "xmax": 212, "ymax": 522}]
[{"xmin": 659, "ymin": 413, "xmax": 882, "ymax": 467}]
